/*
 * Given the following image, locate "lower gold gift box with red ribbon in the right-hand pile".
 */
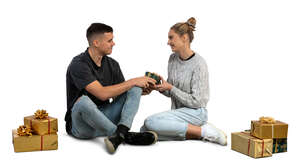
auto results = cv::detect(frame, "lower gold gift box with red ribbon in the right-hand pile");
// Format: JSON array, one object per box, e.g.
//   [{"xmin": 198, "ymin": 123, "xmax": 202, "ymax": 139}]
[{"xmin": 231, "ymin": 132, "xmax": 273, "ymax": 158}]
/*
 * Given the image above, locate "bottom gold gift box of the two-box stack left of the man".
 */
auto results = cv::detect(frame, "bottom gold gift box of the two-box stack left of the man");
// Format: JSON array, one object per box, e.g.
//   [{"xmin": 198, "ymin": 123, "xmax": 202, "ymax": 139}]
[{"xmin": 12, "ymin": 130, "xmax": 58, "ymax": 152}]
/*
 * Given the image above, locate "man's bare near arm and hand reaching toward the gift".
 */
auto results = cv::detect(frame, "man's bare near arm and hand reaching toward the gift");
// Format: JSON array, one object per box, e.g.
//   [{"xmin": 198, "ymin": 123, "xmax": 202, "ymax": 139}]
[{"xmin": 85, "ymin": 77, "xmax": 156, "ymax": 101}]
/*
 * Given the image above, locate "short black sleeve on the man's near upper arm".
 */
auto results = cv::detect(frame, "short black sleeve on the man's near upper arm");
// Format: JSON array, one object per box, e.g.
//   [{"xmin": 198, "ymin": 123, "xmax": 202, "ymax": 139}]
[{"xmin": 70, "ymin": 62, "xmax": 96, "ymax": 90}]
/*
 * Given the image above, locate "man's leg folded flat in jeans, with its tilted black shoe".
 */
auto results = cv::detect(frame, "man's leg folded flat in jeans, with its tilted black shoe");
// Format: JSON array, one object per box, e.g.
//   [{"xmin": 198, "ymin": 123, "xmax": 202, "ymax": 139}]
[{"xmin": 72, "ymin": 96, "xmax": 129, "ymax": 153}]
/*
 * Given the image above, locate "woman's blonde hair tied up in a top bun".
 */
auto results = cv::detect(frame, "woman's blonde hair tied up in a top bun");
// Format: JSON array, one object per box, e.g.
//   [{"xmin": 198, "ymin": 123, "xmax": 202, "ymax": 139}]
[{"xmin": 171, "ymin": 17, "xmax": 196, "ymax": 43}]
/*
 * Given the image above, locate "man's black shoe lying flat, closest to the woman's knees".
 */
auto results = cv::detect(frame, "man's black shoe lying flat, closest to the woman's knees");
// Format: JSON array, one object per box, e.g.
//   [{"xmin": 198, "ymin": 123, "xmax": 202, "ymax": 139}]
[{"xmin": 125, "ymin": 131, "xmax": 157, "ymax": 145}]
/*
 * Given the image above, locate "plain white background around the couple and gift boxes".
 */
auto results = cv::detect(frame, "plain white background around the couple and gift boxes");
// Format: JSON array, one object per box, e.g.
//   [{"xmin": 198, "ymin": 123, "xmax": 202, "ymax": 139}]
[{"xmin": 0, "ymin": 0, "xmax": 300, "ymax": 167}]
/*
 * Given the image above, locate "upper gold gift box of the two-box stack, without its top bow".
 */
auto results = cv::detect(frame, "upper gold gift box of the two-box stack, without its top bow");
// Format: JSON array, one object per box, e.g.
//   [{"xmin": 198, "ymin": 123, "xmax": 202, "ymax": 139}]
[{"xmin": 24, "ymin": 115, "xmax": 58, "ymax": 135}]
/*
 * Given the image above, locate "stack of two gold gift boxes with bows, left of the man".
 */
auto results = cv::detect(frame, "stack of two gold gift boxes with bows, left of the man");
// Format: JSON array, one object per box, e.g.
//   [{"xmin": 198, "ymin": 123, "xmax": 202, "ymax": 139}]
[{"xmin": 12, "ymin": 110, "xmax": 58, "ymax": 152}]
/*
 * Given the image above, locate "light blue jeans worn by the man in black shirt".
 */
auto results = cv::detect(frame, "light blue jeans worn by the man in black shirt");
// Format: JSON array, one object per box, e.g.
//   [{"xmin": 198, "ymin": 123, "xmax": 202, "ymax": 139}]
[{"xmin": 71, "ymin": 87, "xmax": 142, "ymax": 139}]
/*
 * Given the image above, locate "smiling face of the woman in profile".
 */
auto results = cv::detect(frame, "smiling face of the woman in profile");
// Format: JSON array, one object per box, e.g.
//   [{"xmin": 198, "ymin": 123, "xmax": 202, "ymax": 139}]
[{"xmin": 168, "ymin": 29, "xmax": 184, "ymax": 52}]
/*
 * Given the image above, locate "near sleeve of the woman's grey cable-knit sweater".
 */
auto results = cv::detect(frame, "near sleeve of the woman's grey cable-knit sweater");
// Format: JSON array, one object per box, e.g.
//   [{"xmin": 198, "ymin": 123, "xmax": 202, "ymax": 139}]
[{"xmin": 170, "ymin": 63, "xmax": 209, "ymax": 108}]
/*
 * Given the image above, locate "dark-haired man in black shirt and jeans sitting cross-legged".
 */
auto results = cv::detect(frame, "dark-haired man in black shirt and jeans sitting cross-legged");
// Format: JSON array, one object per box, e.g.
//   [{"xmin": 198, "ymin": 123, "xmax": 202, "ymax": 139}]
[{"xmin": 65, "ymin": 23, "xmax": 157, "ymax": 153}]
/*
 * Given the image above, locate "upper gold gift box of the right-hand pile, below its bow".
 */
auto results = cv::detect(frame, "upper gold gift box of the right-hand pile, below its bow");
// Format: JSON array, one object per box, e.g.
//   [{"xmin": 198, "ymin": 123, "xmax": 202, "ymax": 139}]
[{"xmin": 251, "ymin": 121, "xmax": 288, "ymax": 139}]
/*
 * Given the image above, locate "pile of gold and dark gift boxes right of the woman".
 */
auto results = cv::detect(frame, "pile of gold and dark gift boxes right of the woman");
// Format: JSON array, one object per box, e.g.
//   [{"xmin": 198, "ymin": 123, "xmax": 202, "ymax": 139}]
[{"xmin": 231, "ymin": 117, "xmax": 288, "ymax": 158}]
